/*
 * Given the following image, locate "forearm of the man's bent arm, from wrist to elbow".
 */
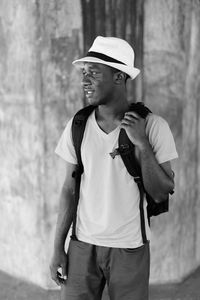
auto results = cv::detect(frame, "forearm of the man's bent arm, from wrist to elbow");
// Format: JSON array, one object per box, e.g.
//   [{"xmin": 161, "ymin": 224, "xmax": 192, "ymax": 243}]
[{"xmin": 140, "ymin": 141, "xmax": 174, "ymax": 202}]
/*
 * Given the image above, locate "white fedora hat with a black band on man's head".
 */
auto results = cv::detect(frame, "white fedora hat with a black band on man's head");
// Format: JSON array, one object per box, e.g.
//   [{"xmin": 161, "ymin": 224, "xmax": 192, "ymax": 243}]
[{"xmin": 72, "ymin": 36, "xmax": 140, "ymax": 79}]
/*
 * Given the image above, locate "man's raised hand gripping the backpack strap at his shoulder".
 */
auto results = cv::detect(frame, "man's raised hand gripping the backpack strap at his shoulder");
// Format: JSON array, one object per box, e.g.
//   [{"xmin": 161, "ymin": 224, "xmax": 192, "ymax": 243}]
[{"xmin": 121, "ymin": 111, "xmax": 148, "ymax": 149}]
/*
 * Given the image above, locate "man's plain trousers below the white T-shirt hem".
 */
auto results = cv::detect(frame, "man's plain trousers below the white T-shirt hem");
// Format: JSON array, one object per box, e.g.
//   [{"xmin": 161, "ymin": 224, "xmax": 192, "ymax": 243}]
[{"xmin": 61, "ymin": 240, "xmax": 150, "ymax": 300}]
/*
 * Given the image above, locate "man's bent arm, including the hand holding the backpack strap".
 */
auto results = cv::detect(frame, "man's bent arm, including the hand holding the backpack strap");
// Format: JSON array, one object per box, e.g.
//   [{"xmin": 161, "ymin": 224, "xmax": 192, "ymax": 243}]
[{"xmin": 121, "ymin": 112, "xmax": 174, "ymax": 202}]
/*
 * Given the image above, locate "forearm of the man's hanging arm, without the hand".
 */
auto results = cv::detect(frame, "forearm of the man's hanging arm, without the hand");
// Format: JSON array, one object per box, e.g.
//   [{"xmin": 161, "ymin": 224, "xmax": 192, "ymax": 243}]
[{"xmin": 54, "ymin": 187, "xmax": 74, "ymax": 251}]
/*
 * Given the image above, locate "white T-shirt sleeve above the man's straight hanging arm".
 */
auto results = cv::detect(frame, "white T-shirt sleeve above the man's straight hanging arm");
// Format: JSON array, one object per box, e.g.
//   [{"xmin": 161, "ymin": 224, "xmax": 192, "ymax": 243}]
[{"xmin": 55, "ymin": 119, "xmax": 77, "ymax": 164}]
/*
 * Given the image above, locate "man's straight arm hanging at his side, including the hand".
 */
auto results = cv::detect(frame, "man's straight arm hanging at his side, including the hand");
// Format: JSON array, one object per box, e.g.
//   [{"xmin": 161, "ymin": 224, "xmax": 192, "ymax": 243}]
[{"xmin": 50, "ymin": 163, "xmax": 76, "ymax": 285}]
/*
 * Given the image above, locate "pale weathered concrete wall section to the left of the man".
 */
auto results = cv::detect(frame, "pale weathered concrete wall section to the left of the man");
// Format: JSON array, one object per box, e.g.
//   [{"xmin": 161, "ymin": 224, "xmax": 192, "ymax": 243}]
[{"xmin": 0, "ymin": 0, "xmax": 82, "ymax": 287}]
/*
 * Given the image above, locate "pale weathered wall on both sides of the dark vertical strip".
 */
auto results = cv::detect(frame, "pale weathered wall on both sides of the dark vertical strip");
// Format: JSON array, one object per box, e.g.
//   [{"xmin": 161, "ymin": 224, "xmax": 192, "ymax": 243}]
[{"xmin": 0, "ymin": 0, "xmax": 200, "ymax": 287}]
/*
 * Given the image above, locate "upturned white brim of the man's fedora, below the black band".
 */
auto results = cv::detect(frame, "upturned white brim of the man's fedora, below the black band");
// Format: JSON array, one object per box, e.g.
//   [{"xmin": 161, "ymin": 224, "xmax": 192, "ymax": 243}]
[{"xmin": 72, "ymin": 56, "xmax": 140, "ymax": 80}]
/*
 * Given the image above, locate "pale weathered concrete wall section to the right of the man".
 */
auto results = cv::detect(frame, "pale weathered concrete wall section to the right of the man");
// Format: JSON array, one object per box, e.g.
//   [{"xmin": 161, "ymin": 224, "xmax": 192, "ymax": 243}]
[{"xmin": 144, "ymin": 0, "xmax": 200, "ymax": 282}]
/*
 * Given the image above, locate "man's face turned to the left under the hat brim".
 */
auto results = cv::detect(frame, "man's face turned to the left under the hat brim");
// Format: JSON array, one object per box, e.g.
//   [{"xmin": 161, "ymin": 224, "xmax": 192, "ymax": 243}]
[{"xmin": 82, "ymin": 63, "xmax": 114, "ymax": 105}]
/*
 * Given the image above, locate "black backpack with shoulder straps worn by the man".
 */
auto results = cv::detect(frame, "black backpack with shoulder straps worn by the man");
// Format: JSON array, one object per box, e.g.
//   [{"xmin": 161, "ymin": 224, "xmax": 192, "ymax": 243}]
[{"xmin": 72, "ymin": 102, "xmax": 172, "ymax": 243}]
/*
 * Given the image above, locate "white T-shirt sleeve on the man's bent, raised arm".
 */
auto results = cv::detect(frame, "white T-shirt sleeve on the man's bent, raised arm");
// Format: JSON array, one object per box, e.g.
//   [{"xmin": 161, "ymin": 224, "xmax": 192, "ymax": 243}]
[{"xmin": 146, "ymin": 114, "xmax": 178, "ymax": 164}]
